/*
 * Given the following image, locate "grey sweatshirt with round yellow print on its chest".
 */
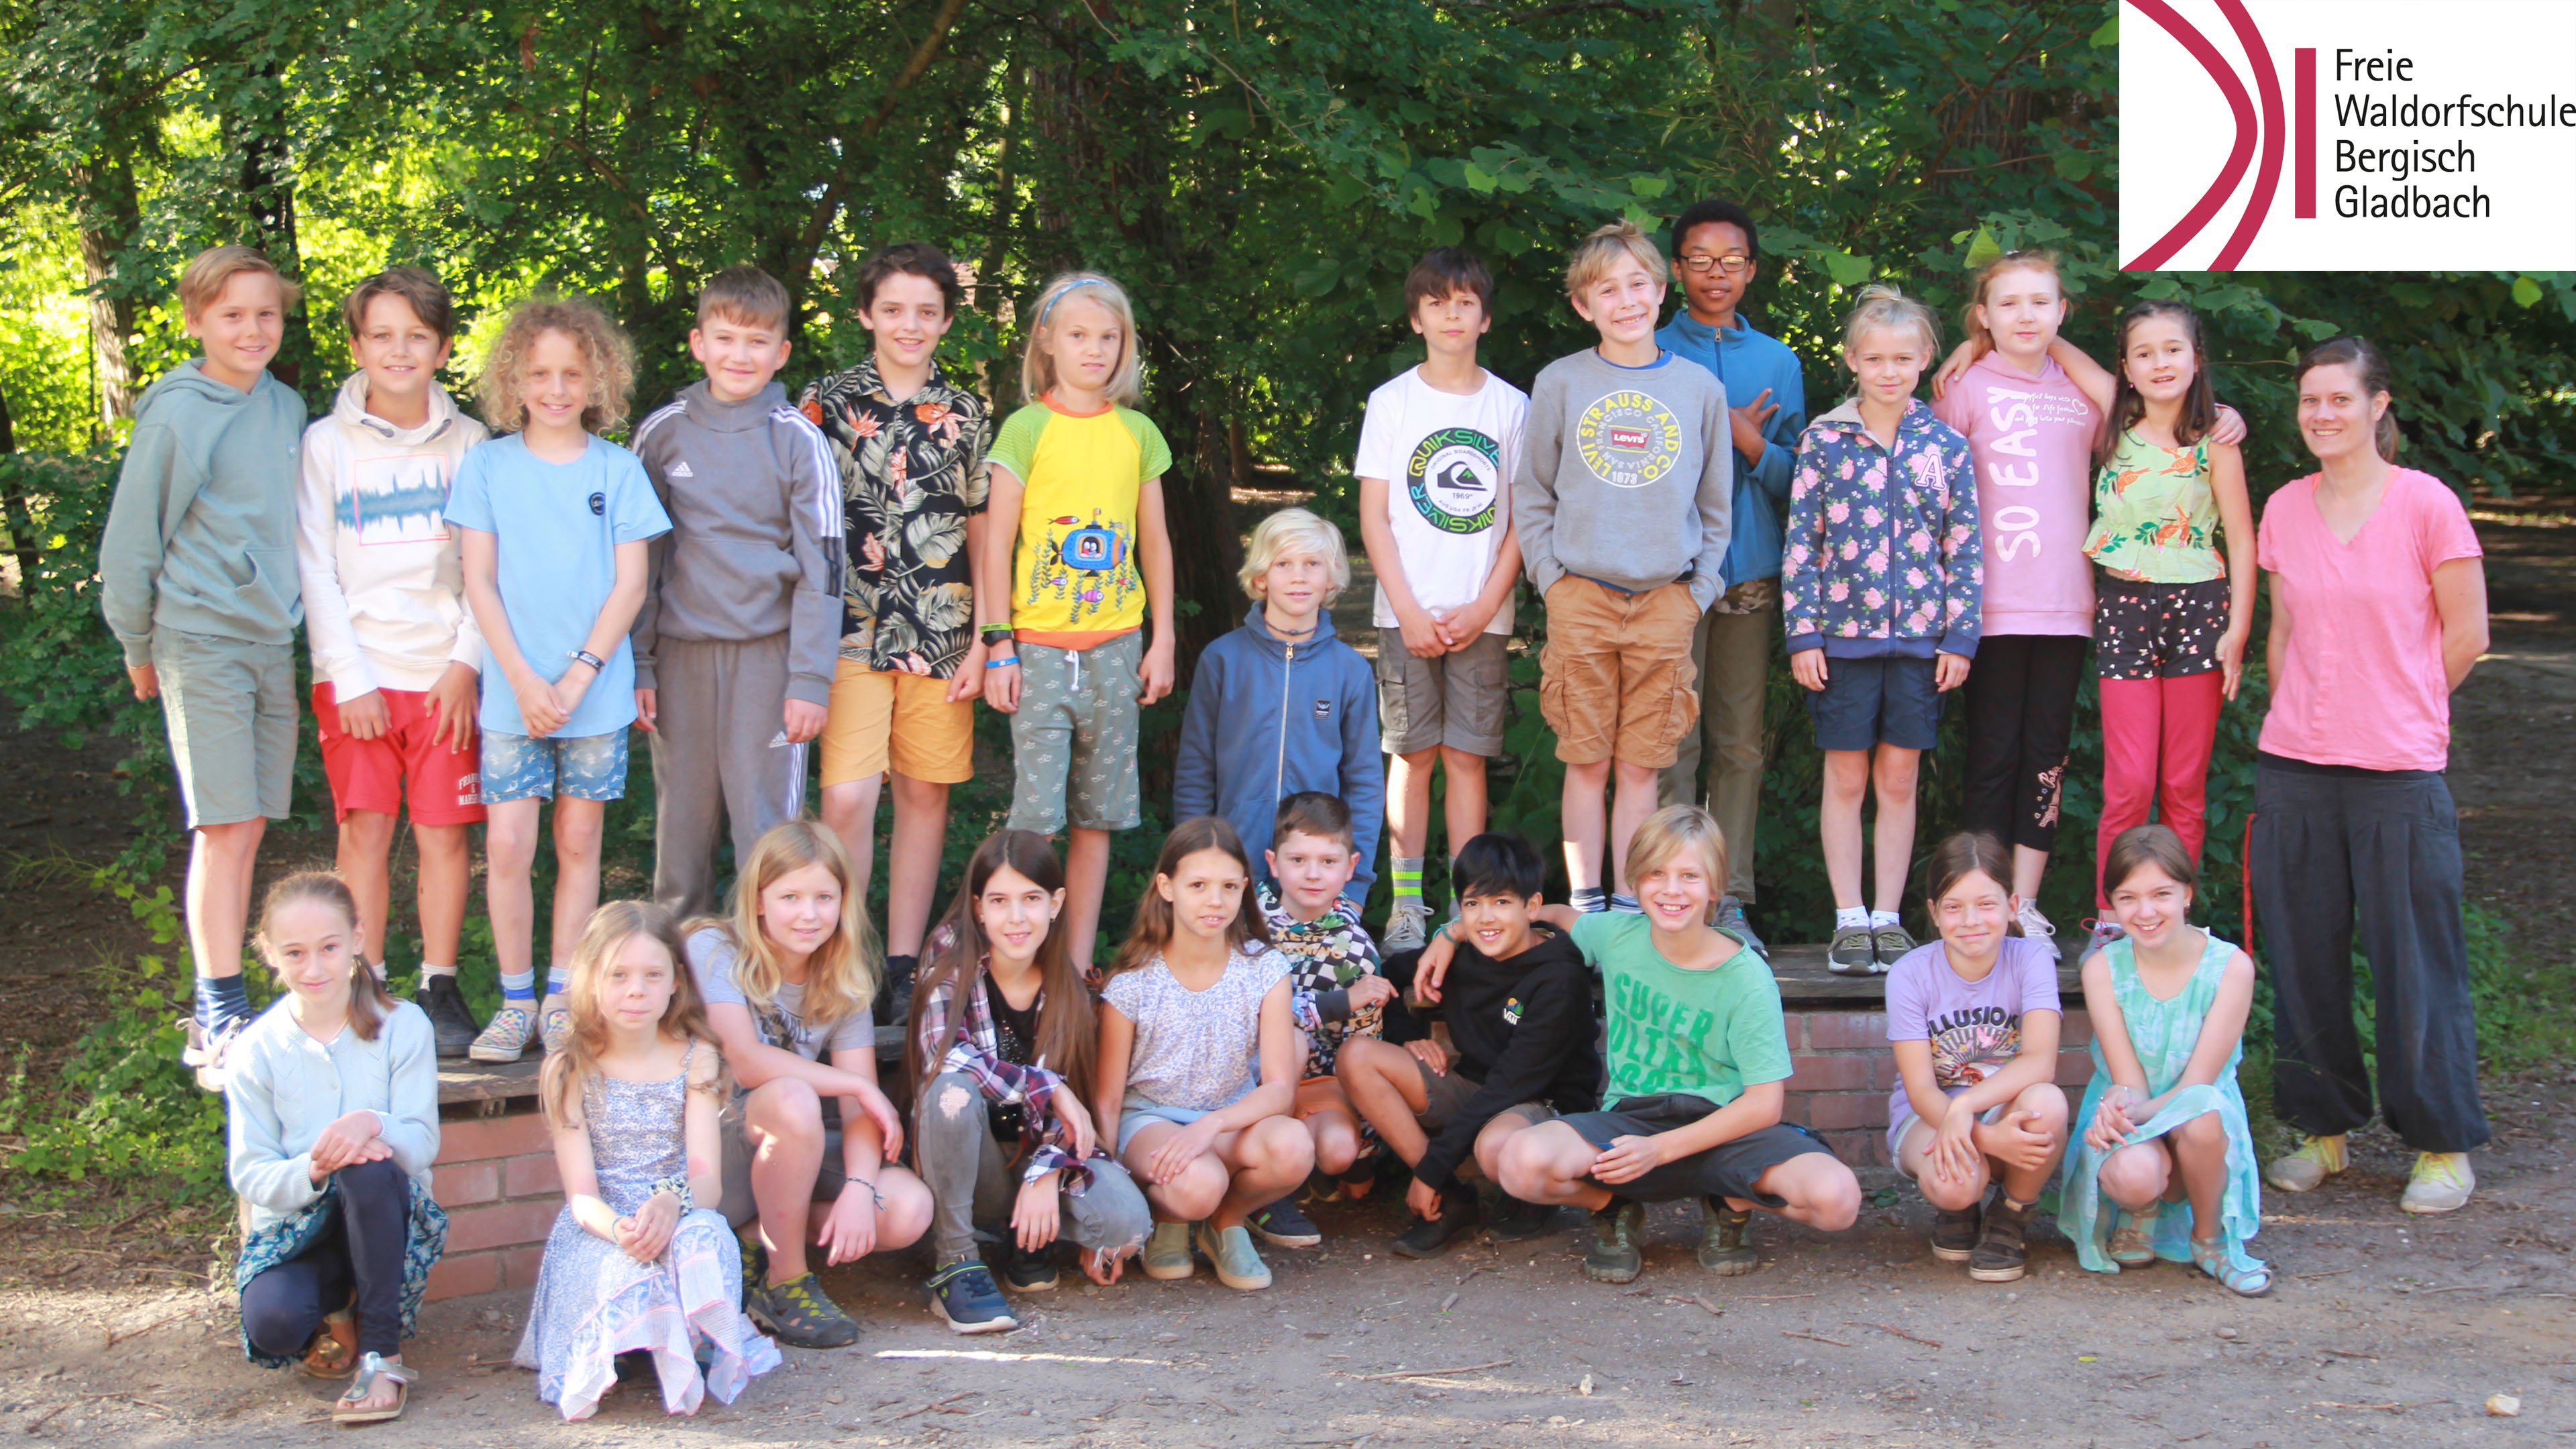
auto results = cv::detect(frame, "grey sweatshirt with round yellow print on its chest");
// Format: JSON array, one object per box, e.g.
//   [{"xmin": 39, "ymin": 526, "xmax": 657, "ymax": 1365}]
[{"xmin": 1512, "ymin": 348, "xmax": 1733, "ymax": 611}]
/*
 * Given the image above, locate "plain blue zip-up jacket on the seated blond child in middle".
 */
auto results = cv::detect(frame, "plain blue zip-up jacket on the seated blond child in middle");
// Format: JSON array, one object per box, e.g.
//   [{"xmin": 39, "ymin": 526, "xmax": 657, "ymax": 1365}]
[{"xmin": 1172, "ymin": 603, "xmax": 1386, "ymax": 892}]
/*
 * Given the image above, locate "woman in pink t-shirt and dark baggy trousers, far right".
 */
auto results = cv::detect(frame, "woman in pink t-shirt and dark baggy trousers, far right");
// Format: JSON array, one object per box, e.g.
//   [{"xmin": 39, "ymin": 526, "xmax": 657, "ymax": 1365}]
[{"xmin": 2251, "ymin": 337, "xmax": 2488, "ymax": 1212}]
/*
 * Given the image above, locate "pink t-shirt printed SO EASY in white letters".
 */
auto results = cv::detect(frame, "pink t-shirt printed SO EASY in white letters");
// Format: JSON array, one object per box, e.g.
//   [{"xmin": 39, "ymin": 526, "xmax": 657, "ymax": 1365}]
[{"xmin": 1932, "ymin": 354, "xmax": 2102, "ymax": 629}]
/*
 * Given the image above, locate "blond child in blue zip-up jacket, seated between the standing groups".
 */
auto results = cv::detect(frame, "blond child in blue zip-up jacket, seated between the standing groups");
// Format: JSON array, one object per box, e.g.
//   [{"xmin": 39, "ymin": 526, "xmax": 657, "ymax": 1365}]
[{"xmin": 1172, "ymin": 508, "xmax": 1386, "ymax": 905}]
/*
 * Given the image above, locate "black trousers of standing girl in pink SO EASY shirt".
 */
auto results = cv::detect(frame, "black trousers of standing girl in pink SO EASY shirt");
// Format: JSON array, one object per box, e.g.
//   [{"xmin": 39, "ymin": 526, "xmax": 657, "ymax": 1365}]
[{"xmin": 1960, "ymin": 634, "xmax": 2092, "ymax": 851}]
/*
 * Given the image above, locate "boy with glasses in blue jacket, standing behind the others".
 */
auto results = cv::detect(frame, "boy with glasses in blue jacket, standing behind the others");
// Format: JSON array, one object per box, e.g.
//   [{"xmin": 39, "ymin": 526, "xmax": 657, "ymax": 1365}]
[{"xmin": 1654, "ymin": 201, "xmax": 1806, "ymax": 951}]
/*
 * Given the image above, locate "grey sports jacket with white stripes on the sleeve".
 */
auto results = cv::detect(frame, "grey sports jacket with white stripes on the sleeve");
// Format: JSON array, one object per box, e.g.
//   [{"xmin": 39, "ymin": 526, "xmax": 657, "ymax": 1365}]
[{"xmin": 634, "ymin": 382, "xmax": 843, "ymax": 704}]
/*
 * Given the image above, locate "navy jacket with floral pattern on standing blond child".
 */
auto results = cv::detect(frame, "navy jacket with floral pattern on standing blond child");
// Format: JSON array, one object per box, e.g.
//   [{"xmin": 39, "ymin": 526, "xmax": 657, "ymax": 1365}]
[{"xmin": 1780, "ymin": 397, "xmax": 1986, "ymax": 660}]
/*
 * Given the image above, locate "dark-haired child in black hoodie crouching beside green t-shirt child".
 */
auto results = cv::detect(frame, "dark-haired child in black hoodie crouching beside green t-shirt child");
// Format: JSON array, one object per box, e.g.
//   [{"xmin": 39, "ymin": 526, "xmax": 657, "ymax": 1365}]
[{"xmin": 1334, "ymin": 833, "xmax": 1602, "ymax": 1258}]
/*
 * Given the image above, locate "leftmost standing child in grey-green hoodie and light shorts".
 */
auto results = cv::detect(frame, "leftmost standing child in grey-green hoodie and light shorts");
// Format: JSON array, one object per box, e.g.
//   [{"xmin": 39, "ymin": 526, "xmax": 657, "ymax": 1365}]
[{"xmin": 98, "ymin": 248, "xmax": 309, "ymax": 1088}]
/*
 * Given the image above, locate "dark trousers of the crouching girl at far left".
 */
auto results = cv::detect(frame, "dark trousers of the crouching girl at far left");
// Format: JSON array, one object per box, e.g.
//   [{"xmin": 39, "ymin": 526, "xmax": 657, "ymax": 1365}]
[{"xmin": 242, "ymin": 1158, "xmax": 412, "ymax": 1358}]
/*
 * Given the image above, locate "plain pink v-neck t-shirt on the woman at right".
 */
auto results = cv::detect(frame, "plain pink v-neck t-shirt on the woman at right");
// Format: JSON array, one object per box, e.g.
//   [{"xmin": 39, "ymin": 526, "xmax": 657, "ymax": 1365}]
[{"xmin": 2254, "ymin": 467, "xmax": 2483, "ymax": 771}]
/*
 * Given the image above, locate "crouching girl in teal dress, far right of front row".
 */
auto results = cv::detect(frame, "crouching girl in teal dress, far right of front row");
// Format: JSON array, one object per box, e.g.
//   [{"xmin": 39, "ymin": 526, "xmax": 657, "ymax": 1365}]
[{"xmin": 2058, "ymin": 825, "xmax": 2272, "ymax": 1297}]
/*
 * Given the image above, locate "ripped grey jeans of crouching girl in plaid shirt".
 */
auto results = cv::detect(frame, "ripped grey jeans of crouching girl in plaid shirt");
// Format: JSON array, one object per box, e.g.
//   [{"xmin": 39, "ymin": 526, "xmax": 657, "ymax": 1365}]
[{"xmin": 912, "ymin": 1073, "xmax": 1154, "ymax": 1266}]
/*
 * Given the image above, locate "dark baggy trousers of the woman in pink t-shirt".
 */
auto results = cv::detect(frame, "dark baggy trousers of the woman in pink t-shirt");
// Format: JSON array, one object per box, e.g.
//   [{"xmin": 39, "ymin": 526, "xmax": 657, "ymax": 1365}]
[{"xmin": 2254, "ymin": 755, "xmax": 2488, "ymax": 1152}]
